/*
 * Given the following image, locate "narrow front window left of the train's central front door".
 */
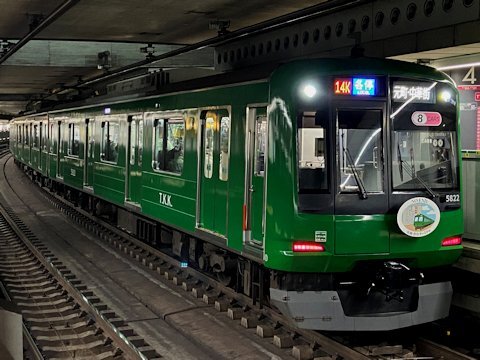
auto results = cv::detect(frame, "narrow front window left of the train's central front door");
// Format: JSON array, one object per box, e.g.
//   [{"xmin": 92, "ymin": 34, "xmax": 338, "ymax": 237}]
[{"xmin": 298, "ymin": 111, "xmax": 328, "ymax": 193}]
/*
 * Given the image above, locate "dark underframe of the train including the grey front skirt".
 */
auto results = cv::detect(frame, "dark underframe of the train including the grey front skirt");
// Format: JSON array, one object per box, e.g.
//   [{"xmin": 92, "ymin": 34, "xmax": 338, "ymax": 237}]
[{"xmin": 21, "ymin": 163, "xmax": 453, "ymax": 331}]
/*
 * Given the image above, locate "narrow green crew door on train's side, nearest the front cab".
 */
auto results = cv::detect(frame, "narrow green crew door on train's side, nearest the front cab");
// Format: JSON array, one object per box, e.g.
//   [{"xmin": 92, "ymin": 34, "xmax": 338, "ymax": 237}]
[{"xmin": 243, "ymin": 106, "xmax": 267, "ymax": 246}]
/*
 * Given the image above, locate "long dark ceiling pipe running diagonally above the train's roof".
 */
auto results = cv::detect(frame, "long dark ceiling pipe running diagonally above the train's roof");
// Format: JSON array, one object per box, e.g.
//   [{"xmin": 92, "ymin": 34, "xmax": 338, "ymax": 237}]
[{"xmin": 77, "ymin": 0, "xmax": 372, "ymax": 87}]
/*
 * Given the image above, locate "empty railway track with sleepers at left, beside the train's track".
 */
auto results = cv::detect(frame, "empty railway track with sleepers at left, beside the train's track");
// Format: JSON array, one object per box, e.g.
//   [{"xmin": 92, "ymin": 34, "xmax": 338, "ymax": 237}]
[{"xmin": 0, "ymin": 154, "xmax": 160, "ymax": 359}]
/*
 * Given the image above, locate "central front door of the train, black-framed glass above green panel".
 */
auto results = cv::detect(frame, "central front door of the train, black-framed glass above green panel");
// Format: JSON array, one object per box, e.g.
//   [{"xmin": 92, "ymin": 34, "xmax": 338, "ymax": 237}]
[{"xmin": 334, "ymin": 101, "xmax": 390, "ymax": 254}]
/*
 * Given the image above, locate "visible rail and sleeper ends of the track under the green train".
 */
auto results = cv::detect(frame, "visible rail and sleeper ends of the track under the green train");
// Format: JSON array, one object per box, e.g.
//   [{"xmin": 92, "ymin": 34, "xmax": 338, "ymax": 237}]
[{"xmin": 2, "ymin": 150, "xmax": 472, "ymax": 360}]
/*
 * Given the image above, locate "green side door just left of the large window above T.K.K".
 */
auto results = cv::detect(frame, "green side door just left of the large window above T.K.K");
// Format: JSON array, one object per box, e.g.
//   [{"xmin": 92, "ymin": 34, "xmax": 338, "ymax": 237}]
[{"xmin": 125, "ymin": 115, "xmax": 143, "ymax": 203}]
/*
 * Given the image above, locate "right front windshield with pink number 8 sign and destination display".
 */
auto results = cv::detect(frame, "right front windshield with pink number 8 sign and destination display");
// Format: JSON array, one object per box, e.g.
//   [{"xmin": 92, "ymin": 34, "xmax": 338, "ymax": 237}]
[{"xmin": 390, "ymin": 78, "xmax": 459, "ymax": 191}]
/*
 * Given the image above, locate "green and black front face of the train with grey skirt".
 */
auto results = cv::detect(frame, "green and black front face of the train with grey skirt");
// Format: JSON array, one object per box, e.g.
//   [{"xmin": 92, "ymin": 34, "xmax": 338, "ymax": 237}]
[{"xmin": 264, "ymin": 59, "xmax": 463, "ymax": 331}]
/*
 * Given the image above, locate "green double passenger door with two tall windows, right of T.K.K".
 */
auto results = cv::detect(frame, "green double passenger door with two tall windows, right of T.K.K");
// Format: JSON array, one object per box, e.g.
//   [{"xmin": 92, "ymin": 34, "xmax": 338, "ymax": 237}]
[{"xmin": 197, "ymin": 109, "xmax": 230, "ymax": 237}]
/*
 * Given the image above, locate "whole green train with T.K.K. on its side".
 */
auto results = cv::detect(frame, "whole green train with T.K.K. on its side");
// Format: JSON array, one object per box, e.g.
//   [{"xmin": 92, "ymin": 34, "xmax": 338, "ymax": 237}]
[{"xmin": 10, "ymin": 58, "xmax": 463, "ymax": 331}]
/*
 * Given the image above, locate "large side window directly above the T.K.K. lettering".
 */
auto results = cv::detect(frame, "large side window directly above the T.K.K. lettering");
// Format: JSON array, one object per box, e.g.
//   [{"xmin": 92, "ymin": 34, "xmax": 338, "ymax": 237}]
[{"xmin": 153, "ymin": 118, "xmax": 185, "ymax": 174}]
